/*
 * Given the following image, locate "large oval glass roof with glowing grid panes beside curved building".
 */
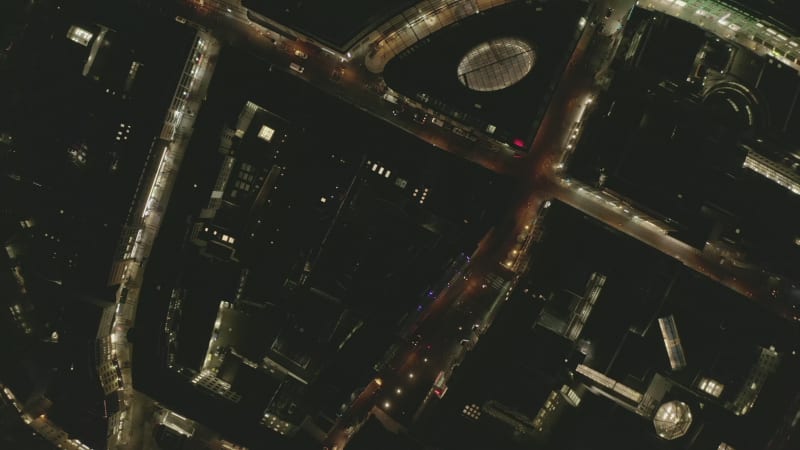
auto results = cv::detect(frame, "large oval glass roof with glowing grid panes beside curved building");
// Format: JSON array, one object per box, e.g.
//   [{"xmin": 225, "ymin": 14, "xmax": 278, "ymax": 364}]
[{"xmin": 458, "ymin": 38, "xmax": 536, "ymax": 92}]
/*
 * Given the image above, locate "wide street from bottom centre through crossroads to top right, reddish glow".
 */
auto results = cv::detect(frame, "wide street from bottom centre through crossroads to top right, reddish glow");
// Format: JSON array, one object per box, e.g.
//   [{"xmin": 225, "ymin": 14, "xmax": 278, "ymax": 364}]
[{"xmin": 326, "ymin": 0, "xmax": 628, "ymax": 449}]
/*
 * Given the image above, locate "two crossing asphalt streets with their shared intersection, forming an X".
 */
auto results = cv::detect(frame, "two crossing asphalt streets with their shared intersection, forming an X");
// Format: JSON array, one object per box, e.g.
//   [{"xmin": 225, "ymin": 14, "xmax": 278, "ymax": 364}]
[{"xmin": 106, "ymin": 0, "xmax": 800, "ymax": 449}]
